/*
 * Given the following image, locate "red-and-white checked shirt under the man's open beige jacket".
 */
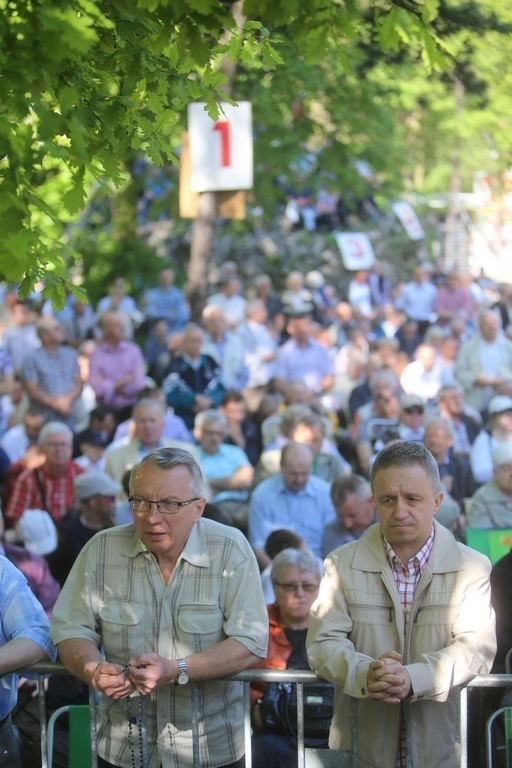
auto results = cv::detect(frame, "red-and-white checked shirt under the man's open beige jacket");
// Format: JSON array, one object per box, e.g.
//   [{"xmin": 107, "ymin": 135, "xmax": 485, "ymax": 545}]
[{"xmin": 384, "ymin": 528, "xmax": 434, "ymax": 768}]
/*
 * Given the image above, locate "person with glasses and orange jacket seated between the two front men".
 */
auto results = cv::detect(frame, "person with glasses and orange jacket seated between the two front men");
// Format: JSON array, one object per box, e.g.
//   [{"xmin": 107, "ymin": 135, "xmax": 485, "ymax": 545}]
[{"xmin": 251, "ymin": 548, "xmax": 328, "ymax": 768}]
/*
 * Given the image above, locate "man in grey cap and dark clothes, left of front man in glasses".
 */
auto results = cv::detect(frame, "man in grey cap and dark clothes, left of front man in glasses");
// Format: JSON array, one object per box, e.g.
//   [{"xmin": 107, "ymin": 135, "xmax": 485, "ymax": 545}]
[{"xmin": 48, "ymin": 470, "xmax": 121, "ymax": 585}]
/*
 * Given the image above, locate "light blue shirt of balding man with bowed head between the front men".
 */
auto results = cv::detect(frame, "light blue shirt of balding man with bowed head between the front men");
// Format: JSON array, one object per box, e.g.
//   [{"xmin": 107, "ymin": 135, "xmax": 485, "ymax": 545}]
[{"xmin": 248, "ymin": 474, "xmax": 336, "ymax": 557}]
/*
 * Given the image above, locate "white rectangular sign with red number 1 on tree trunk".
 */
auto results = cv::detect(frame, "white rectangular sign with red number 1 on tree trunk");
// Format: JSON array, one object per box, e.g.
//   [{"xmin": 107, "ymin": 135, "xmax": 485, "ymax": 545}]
[{"xmin": 188, "ymin": 101, "xmax": 253, "ymax": 192}]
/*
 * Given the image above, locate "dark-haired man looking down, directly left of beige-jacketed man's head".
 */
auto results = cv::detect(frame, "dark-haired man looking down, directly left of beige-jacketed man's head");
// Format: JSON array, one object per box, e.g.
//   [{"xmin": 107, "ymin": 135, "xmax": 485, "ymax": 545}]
[{"xmin": 322, "ymin": 475, "xmax": 377, "ymax": 557}]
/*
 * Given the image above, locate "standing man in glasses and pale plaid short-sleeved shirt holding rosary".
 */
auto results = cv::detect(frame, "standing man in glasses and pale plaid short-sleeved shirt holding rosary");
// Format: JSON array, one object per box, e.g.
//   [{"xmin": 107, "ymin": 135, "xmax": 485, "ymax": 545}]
[{"xmin": 52, "ymin": 448, "xmax": 268, "ymax": 768}]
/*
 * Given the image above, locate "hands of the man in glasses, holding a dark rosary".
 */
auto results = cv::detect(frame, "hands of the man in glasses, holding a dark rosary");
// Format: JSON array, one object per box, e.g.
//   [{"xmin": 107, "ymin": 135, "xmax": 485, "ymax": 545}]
[{"xmin": 91, "ymin": 653, "xmax": 174, "ymax": 701}]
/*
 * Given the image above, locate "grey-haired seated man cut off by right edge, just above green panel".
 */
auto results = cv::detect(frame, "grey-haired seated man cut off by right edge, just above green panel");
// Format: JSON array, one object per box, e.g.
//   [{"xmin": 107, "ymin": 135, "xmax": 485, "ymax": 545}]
[{"xmin": 467, "ymin": 443, "xmax": 512, "ymax": 528}]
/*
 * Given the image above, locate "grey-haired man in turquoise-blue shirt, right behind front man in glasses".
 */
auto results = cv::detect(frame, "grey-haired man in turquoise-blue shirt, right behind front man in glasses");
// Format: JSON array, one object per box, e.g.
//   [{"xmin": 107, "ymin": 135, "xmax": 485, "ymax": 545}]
[{"xmin": 194, "ymin": 410, "xmax": 254, "ymax": 529}]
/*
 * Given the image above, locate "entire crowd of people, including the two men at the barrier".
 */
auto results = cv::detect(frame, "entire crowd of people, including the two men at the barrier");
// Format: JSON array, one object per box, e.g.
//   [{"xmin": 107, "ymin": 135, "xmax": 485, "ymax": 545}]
[{"xmin": 0, "ymin": 262, "xmax": 512, "ymax": 768}]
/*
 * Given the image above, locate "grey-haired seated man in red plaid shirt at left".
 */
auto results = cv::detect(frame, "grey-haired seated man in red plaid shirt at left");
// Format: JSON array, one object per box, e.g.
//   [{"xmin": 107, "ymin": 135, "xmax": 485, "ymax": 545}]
[{"xmin": 5, "ymin": 421, "xmax": 84, "ymax": 525}]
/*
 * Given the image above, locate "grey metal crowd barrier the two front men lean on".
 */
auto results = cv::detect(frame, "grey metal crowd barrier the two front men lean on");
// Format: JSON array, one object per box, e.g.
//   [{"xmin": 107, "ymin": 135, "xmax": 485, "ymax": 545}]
[{"xmin": 21, "ymin": 663, "xmax": 512, "ymax": 768}]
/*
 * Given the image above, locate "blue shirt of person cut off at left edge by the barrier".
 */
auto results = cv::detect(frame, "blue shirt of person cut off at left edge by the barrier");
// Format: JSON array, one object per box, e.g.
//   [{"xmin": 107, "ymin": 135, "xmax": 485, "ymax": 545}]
[{"xmin": 0, "ymin": 555, "xmax": 57, "ymax": 720}]
